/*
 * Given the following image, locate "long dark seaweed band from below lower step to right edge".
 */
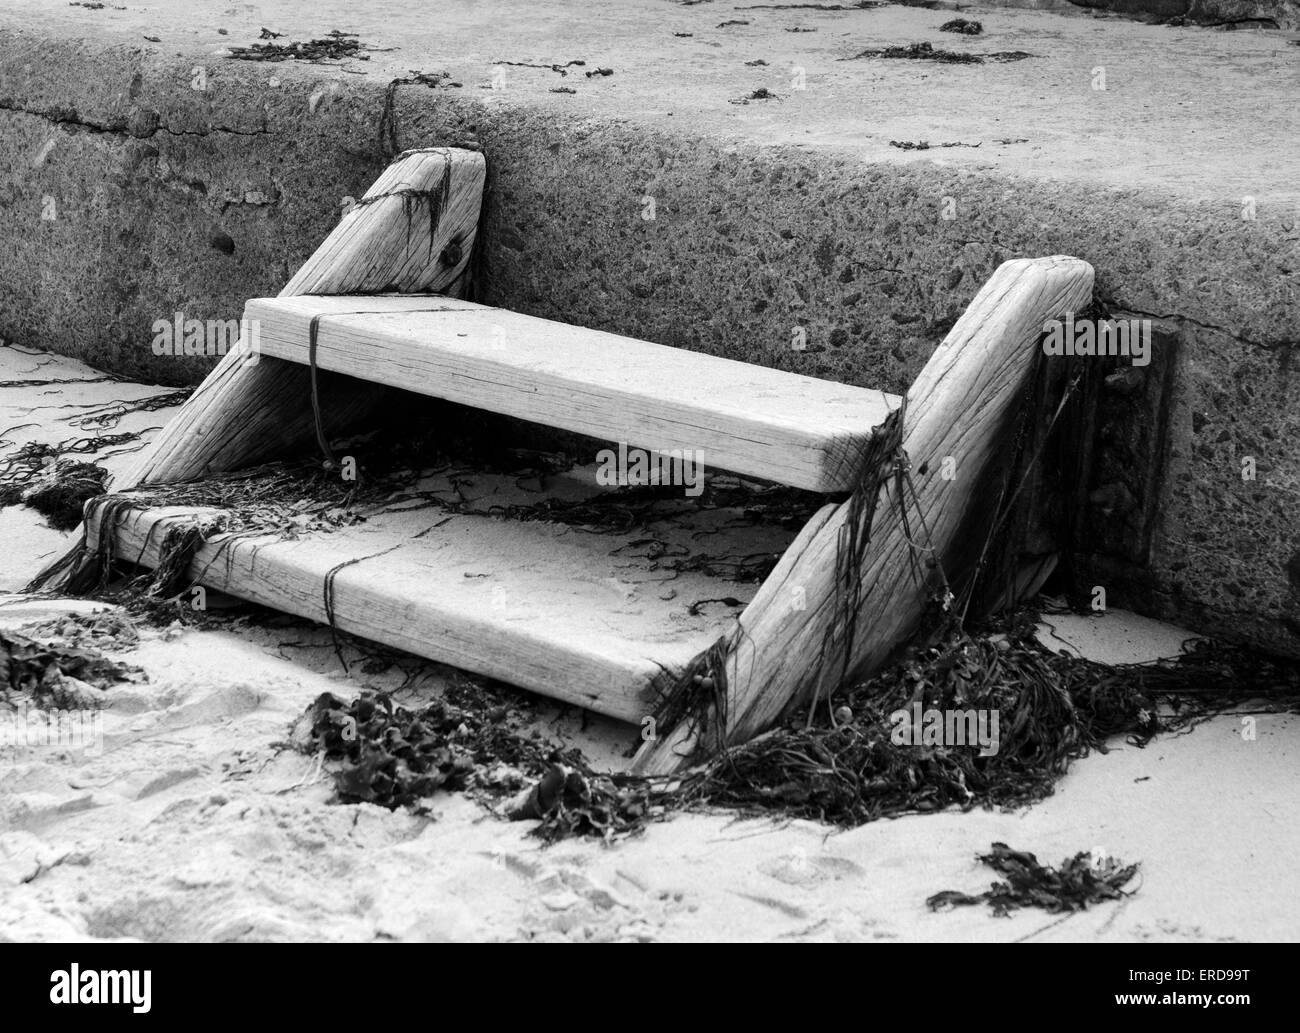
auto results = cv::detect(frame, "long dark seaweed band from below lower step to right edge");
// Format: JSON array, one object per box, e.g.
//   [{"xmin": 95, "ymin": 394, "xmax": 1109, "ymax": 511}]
[{"xmin": 295, "ymin": 619, "xmax": 1300, "ymax": 842}]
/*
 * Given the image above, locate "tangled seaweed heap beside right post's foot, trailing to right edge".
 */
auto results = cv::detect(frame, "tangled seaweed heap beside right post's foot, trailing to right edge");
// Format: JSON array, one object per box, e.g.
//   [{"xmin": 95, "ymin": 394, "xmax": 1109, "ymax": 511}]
[{"xmin": 686, "ymin": 634, "xmax": 1300, "ymax": 825}]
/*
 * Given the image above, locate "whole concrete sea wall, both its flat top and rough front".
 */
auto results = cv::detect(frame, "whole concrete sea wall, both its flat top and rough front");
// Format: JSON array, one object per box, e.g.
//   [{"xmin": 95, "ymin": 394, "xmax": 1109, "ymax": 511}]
[{"xmin": 0, "ymin": 0, "xmax": 1300, "ymax": 652}]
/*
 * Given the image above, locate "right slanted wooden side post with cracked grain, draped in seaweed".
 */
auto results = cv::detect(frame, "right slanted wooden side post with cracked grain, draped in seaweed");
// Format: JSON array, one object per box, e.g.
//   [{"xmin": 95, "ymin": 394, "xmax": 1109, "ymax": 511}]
[{"xmin": 636, "ymin": 256, "xmax": 1092, "ymax": 773}]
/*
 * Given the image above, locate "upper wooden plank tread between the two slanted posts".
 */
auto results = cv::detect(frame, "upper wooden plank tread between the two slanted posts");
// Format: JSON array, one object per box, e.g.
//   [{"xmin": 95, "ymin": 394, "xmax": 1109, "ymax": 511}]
[{"xmin": 244, "ymin": 295, "xmax": 898, "ymax": 491}]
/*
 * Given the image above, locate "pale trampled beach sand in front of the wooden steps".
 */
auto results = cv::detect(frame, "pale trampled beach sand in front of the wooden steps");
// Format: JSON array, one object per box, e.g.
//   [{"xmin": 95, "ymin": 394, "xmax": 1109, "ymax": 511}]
[{"xmin": 0, "ymin": 348, "xmax": 1300, "ymax": 941}]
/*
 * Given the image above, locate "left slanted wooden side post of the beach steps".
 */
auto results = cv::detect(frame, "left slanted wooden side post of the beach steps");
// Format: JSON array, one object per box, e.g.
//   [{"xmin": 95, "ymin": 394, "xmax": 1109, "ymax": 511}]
[{"xmin": 111, "ymin": 148, "xmax": 486, "ymax": 491}]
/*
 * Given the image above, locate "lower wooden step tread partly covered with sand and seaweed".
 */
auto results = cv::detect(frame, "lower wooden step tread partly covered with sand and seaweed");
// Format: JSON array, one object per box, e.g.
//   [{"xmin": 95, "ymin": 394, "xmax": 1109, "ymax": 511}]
[{"xmin": 88, "ymin": 466, "xmax": 796, "ymax": 722}]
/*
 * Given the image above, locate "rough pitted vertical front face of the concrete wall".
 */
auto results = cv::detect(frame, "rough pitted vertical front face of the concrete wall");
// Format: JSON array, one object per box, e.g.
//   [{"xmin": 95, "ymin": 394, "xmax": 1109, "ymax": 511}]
[{"xmin": 0, "ymin": 30, "xmax": 1300, "ymax": 654}]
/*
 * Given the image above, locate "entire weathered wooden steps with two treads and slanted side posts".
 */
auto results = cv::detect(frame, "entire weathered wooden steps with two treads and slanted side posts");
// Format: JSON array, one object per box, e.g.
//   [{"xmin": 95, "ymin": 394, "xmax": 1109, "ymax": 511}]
[{"xmin": 38, "ymin": 148, "xmax": 1092, "ymax": 773}]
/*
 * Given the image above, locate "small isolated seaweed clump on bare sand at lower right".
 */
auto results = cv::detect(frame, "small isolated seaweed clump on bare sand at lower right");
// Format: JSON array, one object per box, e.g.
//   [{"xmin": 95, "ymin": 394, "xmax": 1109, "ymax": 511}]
[{"xmin": 926, "ymin": 843, "xmax": 1139, "ymax": 917}]
